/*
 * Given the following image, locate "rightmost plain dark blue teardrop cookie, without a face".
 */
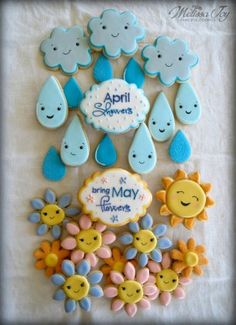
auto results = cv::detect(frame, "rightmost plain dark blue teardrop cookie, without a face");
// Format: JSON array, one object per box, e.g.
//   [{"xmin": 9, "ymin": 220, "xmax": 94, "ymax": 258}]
[{"xmin": 168, "ymin": 130, "xmax": 192, "ymax": 163}]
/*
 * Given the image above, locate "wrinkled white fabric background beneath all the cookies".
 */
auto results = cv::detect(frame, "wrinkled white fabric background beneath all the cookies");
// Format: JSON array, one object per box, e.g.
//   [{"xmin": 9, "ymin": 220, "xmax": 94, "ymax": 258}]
[{"xmin": 2, "ymin": 1, "xmax": 235, "ymax": 323}]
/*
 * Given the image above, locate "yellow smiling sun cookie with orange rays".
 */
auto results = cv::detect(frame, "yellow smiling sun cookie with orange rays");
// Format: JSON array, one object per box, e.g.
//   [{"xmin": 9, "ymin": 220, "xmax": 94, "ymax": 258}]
[{"xmin": 156, "ymin": 169, "xmax": 214, "ymax": 229}]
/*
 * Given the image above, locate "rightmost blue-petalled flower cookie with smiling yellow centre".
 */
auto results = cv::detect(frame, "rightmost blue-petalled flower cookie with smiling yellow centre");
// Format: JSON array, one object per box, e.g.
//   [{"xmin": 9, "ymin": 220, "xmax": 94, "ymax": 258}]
[{"xmin": 119, "ymin": 214, "xmax": 172, "ymax": 267}]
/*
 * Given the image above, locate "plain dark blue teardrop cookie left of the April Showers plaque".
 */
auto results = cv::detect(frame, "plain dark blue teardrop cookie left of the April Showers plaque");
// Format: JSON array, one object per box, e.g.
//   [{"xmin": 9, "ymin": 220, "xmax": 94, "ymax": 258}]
[{"xmin": 64, "ymin": 77, "xmax": 84, "ymax": 109}]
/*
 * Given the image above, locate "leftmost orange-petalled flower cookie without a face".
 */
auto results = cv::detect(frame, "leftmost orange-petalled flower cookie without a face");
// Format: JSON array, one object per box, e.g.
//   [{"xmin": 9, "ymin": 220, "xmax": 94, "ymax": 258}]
[{"xmin": 34, "ymin": 240, "xmax": 70, "ymax": 276}]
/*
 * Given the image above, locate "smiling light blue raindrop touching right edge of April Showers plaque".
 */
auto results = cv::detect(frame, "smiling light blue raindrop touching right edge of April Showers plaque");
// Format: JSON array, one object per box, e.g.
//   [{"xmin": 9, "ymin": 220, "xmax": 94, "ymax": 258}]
[{"xmin": 148, "ymin": 92, "xmax": 175, "ymax": 142}]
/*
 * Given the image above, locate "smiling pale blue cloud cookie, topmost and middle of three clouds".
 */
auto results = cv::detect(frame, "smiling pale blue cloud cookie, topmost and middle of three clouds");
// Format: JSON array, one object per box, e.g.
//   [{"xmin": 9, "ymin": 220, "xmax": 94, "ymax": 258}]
[{"xmin": 88, "ymin": 9, "xmax": 145, "ymax": 59}]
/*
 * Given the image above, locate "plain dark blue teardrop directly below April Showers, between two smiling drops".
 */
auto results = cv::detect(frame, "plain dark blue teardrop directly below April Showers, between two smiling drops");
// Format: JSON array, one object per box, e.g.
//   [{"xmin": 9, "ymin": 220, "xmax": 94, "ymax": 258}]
[{"xmin": 95, "ymin": 134, "xmax": 117, "ymax": 167}]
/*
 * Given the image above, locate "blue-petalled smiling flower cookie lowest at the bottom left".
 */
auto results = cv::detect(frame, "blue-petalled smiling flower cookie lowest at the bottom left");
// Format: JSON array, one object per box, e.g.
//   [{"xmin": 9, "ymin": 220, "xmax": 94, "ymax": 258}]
[{"xmin": 51, "ymin": 260, "xmax": 103, "ymax": 313}]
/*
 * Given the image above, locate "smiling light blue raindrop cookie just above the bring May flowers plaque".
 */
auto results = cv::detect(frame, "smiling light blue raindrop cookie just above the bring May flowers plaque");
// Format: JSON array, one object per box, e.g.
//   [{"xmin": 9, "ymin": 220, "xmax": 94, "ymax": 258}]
[{"xmin": 128, "ymin": 123, "xmax": 157, "ymax": 174}]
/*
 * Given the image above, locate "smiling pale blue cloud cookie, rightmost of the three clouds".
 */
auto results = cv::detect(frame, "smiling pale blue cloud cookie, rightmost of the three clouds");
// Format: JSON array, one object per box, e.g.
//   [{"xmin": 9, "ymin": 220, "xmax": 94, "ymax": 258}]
[{"xmin": 142, "ymin": 36, "xmax": 198, "ymax": 87}]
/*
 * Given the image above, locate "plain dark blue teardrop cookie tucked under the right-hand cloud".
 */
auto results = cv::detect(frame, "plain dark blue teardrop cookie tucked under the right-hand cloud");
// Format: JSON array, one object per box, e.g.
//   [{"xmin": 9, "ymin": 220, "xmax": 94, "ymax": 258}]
[{"xmin": 123, "ymin": 58, "xmax": 145, "ymax": 88}]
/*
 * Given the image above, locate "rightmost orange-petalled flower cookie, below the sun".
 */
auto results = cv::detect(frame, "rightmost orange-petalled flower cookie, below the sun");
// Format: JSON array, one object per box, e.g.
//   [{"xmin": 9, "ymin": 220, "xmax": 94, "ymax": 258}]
[{"xmin": 170, "ymin": 238, "xmax": 208, "ymax": 278}]
